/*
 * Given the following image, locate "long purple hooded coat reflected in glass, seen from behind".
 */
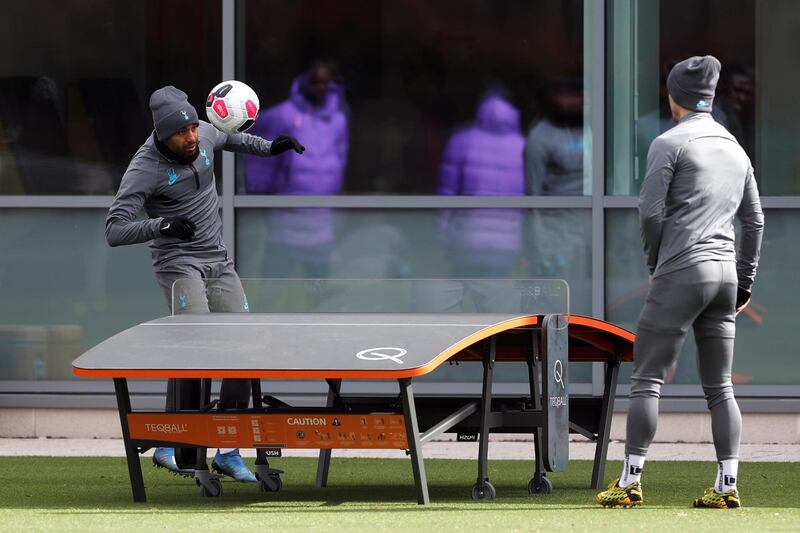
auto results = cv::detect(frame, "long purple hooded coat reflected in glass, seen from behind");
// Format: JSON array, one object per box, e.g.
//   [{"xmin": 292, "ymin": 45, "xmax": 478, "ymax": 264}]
[{"xmin": 437, "ymin": 92, "xmax": 525, "ymax": 278}]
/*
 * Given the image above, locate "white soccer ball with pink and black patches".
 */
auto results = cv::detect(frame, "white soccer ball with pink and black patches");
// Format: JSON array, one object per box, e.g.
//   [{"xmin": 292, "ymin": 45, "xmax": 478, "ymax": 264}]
[{"xmin": 206, "ymin": 80, "xmax": 258, "ymax": 133}]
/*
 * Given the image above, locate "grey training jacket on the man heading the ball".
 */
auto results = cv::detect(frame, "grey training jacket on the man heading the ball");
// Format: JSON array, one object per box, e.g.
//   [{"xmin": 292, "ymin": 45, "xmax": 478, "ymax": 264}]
[{"xmin": 106, "ymin": 120, "xmax": 272, "ymax": 270}]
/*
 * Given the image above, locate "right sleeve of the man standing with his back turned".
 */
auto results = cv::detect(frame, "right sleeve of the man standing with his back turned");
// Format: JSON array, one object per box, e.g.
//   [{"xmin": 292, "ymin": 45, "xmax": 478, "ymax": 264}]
[{"xmin": 736, "ymin": 167, "xmax": 764, "ymax": 291}]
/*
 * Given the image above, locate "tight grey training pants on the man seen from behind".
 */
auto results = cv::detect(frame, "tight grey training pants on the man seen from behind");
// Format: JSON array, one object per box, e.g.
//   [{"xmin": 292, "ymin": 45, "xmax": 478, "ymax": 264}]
[{"xmin": 625, "ymin": 261, "xmax": 742, "ymax": 461}]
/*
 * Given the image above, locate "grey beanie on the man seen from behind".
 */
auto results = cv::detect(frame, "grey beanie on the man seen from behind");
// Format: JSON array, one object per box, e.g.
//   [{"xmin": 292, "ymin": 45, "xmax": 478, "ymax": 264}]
[{"xmin": 667, "ymin": 56, "xmax": 722, "ymax": 113}]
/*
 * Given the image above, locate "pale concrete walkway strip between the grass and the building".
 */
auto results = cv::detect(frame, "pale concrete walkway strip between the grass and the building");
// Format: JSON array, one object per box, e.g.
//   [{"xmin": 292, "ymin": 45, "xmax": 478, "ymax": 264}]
[{"xmin": 6, "ymin": 435, "xmax": 800, "ymax": 462}]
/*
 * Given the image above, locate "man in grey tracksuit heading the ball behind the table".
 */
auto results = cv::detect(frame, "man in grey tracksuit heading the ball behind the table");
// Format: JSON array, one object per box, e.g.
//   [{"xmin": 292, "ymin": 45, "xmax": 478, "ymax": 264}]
[{"xmin": 106, "ymin": 86, "xmax": 304, "ymax": 481}]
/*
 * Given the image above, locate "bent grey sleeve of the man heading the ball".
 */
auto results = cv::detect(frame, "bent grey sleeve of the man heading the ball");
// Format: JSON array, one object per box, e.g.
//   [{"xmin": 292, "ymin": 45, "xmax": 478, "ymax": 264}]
[{"xmin": 106, "ymin": 167, "xmax": 162, "ymax": 246}]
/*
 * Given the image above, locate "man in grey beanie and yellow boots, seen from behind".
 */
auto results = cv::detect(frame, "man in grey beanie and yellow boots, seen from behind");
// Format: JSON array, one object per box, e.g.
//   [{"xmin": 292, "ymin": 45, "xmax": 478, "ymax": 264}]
[{"xmin": 596, "ymin": 56, "xmax": 764, "ymax": 509}]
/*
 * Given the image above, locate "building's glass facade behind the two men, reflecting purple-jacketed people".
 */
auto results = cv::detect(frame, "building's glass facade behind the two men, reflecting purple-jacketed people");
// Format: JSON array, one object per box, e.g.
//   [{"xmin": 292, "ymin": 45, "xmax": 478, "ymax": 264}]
[{"xmin": 0, "ymin": 0, "xmax": 800, "ymax": 395}]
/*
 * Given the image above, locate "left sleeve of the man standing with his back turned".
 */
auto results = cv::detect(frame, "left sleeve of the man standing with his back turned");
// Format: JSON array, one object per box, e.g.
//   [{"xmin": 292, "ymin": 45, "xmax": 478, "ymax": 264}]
[{"xmin": 639, "ymin": 138, "xmax": 676, "ymax": 274}]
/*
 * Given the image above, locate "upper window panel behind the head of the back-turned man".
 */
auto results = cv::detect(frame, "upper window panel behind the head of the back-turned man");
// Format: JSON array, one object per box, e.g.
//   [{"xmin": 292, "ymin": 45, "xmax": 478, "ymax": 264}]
[{"xmin": 607, "ymin": 0, "xmax": 800, "ymax": 195}]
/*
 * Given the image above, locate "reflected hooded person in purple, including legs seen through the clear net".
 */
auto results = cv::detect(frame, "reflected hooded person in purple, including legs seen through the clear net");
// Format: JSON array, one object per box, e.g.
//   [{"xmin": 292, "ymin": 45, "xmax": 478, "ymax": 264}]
[{"xmin": 414, "ymin": 91, "xmax": 525, "ymax": 312}]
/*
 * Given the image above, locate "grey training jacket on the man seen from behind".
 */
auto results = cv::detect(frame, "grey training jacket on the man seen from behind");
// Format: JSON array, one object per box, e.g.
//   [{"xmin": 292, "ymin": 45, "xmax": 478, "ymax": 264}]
[{"xmin": 639, "ymin": 109, "xmax": 764, "ymax": 290}]
